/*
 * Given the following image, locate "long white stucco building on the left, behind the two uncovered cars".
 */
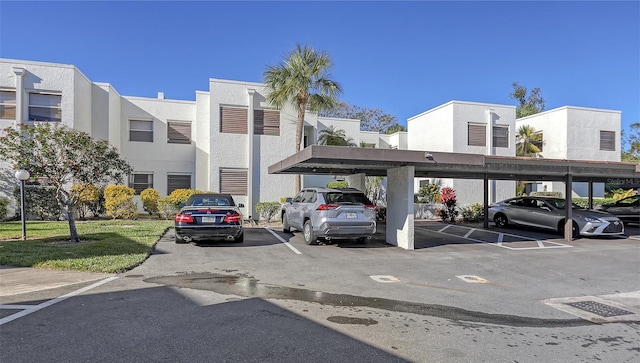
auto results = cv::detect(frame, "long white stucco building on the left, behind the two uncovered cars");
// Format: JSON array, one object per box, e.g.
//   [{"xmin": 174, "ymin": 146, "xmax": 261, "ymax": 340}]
[{"xmin": 0, "ymin": 59, "xmax": 396, "ymax": 219}]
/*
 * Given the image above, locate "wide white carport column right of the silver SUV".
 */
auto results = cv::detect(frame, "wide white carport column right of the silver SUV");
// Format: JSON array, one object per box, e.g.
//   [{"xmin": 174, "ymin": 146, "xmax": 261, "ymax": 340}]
[{"xmin": 386, "ymin": 166, "xmax": 415, "ymax": 250}]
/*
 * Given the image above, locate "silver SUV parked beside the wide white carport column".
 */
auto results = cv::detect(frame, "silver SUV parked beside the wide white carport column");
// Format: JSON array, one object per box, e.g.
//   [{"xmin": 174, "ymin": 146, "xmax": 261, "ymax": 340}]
[{"xmin": 282, "ymin": 187, "xmax": 377, "ymax": 245}]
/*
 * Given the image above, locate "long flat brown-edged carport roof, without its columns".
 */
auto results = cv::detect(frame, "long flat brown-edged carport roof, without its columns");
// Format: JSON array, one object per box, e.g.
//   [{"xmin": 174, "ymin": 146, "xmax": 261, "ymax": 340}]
[{"xmin": 269, "ymin": 145, "xmax": 640, "ymax": 184}]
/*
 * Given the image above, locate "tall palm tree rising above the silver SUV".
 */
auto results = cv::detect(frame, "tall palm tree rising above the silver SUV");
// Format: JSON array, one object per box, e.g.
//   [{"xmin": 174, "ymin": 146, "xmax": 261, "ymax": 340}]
[{"xmin": 263, "ymin": 44, "xmax": 342, "ymax": 193}]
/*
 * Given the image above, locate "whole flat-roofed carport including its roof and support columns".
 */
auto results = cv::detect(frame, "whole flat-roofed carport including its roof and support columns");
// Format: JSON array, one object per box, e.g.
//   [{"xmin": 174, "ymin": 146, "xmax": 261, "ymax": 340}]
[{"xmin": 269, "ymin": 145, "xmax": 640, "ymax": 250}]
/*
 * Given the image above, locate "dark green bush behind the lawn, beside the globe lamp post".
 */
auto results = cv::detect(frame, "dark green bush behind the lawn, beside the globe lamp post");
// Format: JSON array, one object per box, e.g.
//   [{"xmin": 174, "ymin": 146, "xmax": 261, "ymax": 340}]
[{"xmin": 13, "ymin": 185, "xmax": 62, "ymax": 221}]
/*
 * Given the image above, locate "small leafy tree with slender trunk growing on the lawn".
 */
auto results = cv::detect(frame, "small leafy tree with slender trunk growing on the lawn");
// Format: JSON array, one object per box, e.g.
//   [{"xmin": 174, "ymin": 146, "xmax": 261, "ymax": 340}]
[{"xmin": 0, "ymin": 122, "xmax": 132, "ymax": 242}]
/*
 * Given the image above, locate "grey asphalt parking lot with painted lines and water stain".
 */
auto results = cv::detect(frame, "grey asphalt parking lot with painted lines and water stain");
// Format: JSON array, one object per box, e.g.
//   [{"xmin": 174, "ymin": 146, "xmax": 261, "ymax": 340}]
[{"xmin": 0, "ymin": 221, "xmax": 640, "ymax": 362}]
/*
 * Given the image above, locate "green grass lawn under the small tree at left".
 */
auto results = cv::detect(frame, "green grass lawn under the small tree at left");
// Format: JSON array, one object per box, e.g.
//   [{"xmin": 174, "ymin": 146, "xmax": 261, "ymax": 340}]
[{"xmin": 0, "ymin": 220, "xmax": 173, "ymax": 273}]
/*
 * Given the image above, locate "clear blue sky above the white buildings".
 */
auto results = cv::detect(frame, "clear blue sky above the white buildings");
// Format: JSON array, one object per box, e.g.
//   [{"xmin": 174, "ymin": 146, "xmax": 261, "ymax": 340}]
[{"xmin": 0, "ymin": 0, "xmax": 640, "ymax": 138}]
